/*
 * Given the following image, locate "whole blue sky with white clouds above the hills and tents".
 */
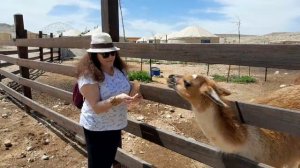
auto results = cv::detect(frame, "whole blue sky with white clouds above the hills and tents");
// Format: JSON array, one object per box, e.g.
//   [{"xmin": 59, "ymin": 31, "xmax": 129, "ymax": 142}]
[{"xmin": 0, "ymin": 0, "xmax": 300, "ymax": 37}]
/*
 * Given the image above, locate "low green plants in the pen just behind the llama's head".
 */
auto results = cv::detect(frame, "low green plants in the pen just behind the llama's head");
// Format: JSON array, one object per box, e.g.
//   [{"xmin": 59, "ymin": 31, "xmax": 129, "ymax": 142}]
[{"xmin": 213, "ymin": 74, "xmax": 256, "ymax": 84}]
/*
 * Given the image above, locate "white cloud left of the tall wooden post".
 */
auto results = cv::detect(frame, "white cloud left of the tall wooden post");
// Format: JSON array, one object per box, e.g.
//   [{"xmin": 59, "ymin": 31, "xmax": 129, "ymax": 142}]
[{"xmin": 0, "ymin": 0, "xmax": 100, "ymax": 32}]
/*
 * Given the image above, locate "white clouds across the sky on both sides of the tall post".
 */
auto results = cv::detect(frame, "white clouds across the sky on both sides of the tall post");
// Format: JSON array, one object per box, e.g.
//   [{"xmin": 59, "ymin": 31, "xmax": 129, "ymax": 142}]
[{"xmin": 0, "ymin": 0, "xmax": 300, "ymax": 36}]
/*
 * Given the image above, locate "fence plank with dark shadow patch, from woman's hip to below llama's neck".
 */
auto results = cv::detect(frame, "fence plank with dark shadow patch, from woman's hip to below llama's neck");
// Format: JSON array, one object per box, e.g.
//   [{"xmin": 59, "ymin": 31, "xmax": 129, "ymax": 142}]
[{"xmin": 125, "ymin": 119, "xmax": 266, "ymax": 168}]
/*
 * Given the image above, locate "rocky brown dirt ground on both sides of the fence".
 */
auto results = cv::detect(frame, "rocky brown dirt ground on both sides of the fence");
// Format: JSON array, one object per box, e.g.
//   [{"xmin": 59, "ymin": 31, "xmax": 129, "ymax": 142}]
[{"xmin": 0, "ymin": 57, "xmax": 300, "ymax": 168}]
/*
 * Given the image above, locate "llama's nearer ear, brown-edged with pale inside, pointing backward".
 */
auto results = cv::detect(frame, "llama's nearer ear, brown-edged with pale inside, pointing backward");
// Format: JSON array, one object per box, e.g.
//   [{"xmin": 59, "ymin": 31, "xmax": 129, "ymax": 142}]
[{"xmin": 200, "ymin": 84, "xmax": 228, "ymax": 107}]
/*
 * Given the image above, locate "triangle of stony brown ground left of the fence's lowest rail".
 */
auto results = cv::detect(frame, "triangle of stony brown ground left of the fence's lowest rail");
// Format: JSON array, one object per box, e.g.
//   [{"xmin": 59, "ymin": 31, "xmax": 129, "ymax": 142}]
[{"xmin": 0, "ymin": 97, "xmax": 86, "ymax": 168}]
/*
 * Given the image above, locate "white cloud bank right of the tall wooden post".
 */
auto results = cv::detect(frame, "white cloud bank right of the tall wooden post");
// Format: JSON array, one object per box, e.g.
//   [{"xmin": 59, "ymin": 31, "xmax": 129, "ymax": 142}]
[{"xmin": 123, "ymin": 0, "xmax": 300, "ymax": 36}]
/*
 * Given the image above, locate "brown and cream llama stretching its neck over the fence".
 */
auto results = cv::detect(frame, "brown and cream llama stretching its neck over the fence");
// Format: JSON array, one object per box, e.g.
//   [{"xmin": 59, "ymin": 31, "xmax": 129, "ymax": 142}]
[{"xmin": 168, "ymin": 75, "xmax": 300, "ymax": 168}]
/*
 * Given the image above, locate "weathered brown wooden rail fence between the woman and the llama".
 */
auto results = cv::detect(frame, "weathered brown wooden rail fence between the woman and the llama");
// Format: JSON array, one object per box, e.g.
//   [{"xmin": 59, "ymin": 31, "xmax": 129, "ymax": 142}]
[{"xmin": 0, "ymin": 15, "xmax": 300, "ymax": 168}]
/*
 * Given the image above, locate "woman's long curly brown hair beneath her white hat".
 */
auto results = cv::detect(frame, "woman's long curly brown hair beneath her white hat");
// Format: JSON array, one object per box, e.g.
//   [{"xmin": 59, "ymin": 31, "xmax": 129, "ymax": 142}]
[{"xmin": 76, "ymin": 52, "xmax": 127, "ymax": 82}]
